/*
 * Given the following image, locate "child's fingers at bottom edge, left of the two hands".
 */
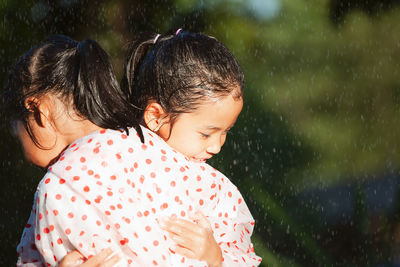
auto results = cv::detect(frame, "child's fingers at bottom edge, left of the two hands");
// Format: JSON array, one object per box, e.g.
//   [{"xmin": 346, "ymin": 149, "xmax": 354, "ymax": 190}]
[{"xmin": 59, "ymin": 248, "xmax": 120, "ymax": 267}]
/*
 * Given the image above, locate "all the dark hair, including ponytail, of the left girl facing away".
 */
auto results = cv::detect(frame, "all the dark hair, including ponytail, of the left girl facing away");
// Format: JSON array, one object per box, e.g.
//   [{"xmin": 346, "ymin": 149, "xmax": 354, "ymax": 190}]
[{"xmin": 2, "ymin": 35, "xmax": 143, "ymax": 146}]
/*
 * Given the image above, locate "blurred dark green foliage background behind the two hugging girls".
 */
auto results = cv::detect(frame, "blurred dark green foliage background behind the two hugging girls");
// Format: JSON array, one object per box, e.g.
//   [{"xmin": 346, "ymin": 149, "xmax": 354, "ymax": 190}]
[{"xmin": 0, "ymin": 0, "xmax": 400, "ymax": 266}]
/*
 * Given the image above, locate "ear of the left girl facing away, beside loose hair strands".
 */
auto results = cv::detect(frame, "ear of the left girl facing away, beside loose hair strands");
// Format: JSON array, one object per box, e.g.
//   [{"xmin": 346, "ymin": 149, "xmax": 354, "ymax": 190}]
[{"xmin": 24, "ymin": 96, "xmax": 51, "ymax": 128}]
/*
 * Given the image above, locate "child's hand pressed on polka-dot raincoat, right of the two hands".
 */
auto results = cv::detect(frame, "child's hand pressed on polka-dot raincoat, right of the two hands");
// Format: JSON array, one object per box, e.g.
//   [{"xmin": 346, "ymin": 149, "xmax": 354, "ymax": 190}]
[{"xmin": 160, "ymin": 212, "xmax": 222, "ymax": 267}]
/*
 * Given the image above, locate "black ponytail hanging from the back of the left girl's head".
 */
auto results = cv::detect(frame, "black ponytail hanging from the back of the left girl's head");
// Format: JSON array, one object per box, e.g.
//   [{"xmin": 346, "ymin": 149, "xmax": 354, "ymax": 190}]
[{"xmin": 73, "ymin": 39, "xmax": 144, "ymax": 142}]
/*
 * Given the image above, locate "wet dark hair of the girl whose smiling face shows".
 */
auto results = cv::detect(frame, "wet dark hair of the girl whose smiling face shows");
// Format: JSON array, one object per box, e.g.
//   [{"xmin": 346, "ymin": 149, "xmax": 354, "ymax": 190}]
[{"xmin": 121, "ymin": 30, "xmax": 244, "ymax": 124}]
